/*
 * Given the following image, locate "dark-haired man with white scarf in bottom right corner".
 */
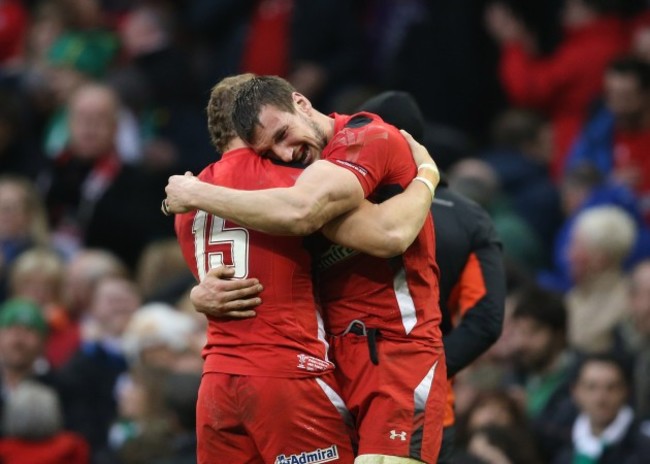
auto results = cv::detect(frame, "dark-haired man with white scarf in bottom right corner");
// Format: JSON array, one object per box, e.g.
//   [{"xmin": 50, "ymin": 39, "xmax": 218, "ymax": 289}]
[{"xmin": 553, "ymin": 355, "xmax": 650, "ymax": 464}]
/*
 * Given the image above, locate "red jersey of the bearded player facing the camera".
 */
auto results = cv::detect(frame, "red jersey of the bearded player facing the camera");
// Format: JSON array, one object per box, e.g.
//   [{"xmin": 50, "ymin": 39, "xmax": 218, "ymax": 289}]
[{"xmin": 318, "ymin": 113, "xmax": 442, "ymax": 346}]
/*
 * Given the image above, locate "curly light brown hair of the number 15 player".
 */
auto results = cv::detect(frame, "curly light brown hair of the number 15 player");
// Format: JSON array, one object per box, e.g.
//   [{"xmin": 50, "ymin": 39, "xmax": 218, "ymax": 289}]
[{"xmin": 205, "ymin": 74, "xmax": 255, "ymax": 153}]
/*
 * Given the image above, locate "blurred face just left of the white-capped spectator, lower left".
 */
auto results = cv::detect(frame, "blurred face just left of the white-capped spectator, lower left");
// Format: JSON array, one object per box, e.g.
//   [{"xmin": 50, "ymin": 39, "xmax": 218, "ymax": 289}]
[{"xmin": 91, "ymin": 277, "xmax": 141, "ymax": 337}]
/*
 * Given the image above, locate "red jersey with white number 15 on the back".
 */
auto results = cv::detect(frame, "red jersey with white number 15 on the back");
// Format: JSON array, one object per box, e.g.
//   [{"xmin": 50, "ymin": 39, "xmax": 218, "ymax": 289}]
[{"xmin": 175, "ymin": 148, "xmax": 334, "ymax": 378}]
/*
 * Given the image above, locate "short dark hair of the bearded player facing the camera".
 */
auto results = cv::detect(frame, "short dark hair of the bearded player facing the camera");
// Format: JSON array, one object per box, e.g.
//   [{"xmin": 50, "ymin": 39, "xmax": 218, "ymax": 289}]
[{"xmin": 232, "ymin": 76, "xmax": 296, "ymax": 143}]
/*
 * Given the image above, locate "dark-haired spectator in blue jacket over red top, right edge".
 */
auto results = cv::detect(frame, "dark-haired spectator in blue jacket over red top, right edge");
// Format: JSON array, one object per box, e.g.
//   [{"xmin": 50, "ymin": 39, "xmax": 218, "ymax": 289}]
[{"xmin": 567, "ymin": 57, "xmax": 650, "ymax": 223}]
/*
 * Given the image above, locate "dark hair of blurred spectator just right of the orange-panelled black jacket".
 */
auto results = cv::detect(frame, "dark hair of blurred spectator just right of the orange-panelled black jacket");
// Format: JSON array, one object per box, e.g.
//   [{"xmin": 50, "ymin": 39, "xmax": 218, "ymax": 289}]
[{"xmin": 512, "ymin": 286, "xmax": 567, "ymax": 332}]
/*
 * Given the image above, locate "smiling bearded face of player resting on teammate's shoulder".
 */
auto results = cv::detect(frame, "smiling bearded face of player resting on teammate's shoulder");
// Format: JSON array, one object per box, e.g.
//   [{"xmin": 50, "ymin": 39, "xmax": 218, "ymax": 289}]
[{"xmin": 252, "ymin": 94, "xmax": 327, "ymax": 165}]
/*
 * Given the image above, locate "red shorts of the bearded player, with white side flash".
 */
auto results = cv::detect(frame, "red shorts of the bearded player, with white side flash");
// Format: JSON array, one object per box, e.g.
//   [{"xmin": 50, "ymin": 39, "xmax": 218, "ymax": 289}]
[{"xmin": 331, "ymin": 333, "xmax": 447, "ymax": 463}]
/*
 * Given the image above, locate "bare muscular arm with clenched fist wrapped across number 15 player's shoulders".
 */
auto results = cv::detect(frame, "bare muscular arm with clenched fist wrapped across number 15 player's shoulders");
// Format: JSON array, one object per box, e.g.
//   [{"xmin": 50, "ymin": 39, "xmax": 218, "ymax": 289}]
[{"xmin": 165, "ymin": 161, "xmax": 364, "ymax": 235}]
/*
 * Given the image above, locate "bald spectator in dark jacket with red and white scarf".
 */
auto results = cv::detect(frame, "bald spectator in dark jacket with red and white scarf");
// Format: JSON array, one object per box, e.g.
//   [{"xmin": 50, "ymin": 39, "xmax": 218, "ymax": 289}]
[{"xmin": 42, "ymin": 84, "xmax": 172, "ymax": 266}]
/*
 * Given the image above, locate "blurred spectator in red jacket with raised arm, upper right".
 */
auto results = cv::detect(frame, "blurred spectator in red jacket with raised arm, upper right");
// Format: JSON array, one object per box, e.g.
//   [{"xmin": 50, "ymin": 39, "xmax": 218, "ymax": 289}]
[{"xmin": 486, "ymin": 0, "xmax": 627, "ymax": 180}]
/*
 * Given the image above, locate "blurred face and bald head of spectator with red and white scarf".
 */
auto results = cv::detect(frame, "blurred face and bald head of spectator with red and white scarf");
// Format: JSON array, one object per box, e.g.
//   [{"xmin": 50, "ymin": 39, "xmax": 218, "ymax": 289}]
[{"xmin": 69, "ymin": 86, "xmax": 118, "ymax": 160}]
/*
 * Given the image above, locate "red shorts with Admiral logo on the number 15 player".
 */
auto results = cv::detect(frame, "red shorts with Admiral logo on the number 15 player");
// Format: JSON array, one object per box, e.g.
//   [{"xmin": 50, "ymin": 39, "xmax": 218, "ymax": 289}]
[{"xmin": 196, "ymin": 372, "xmax": 354, "ymax": 464}]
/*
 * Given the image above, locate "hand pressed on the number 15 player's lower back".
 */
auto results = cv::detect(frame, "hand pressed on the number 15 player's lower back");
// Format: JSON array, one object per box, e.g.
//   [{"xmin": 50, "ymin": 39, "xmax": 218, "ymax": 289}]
[{"xmin": 190, "ymin": 266, "xmax": 263, "ymax": 319}]
